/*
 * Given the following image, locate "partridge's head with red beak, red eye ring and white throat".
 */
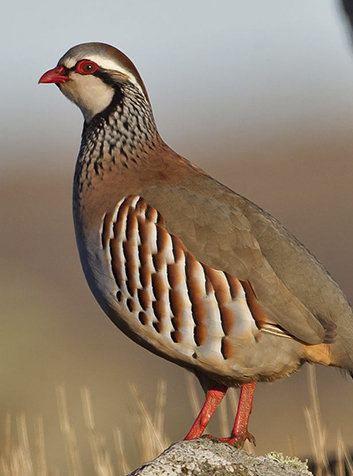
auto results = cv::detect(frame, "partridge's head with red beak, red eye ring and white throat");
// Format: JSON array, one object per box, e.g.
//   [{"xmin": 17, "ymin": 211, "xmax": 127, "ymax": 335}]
[{"xmin": 39, "ymin": 43, "xmax": 149, "ymax": 122}]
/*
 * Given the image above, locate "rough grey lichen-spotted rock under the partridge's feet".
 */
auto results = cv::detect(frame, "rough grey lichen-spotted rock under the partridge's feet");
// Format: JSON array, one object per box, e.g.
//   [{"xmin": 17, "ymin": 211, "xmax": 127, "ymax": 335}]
[{"xmin": 129, "ymin": 438, "xmax": 313, "ymax": 476}]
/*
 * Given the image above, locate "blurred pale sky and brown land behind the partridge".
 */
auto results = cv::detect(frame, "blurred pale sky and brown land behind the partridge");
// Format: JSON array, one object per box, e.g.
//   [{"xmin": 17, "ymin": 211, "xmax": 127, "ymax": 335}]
[{"xmin": 0, "ymin": 0, "xmax": 353, "ymax": 474}]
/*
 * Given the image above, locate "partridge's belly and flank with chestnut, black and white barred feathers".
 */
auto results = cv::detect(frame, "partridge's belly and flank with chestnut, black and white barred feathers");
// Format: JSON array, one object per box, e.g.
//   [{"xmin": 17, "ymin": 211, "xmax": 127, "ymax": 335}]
[{"xmin": 80, "ymin": 197, "xmax": 303, "ymax": 385}]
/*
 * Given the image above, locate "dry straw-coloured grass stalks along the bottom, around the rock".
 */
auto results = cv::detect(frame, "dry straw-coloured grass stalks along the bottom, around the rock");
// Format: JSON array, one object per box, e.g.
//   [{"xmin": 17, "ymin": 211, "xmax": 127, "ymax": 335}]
[{"xmin": 0, "ymin": 366, "xmax": 353, "ymax": 476}]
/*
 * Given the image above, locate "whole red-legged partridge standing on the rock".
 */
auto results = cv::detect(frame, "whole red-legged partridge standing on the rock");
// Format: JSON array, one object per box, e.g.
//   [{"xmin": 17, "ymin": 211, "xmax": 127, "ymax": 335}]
[{"xmin": 40, "ymin": 43, "xmax": 353, "ymax": 446}]
